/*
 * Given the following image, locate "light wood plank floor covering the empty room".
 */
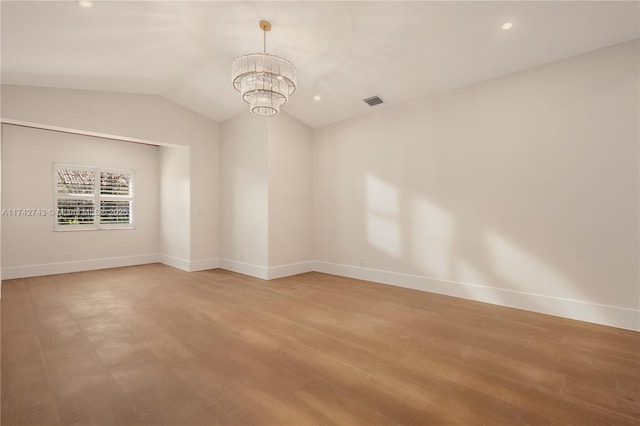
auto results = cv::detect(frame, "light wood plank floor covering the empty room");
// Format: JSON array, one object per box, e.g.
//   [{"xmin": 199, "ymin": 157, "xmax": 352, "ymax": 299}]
[{"xmin": 1, "ymin": 264, "xmax": 640, "ymax": 426}]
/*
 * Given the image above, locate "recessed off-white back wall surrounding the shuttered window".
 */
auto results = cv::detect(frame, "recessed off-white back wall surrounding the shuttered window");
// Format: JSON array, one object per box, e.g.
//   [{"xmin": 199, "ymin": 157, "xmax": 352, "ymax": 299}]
[{"xmin": 2, "ymin": 124, "xmax": 159, "ymax": 278}]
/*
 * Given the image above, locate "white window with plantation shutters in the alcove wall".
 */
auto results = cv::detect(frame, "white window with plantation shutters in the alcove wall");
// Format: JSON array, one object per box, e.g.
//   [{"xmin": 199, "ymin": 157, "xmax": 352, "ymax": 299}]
[{"xmin": 54, "ymin": 163, "xmax": 134, "ymax": 231}]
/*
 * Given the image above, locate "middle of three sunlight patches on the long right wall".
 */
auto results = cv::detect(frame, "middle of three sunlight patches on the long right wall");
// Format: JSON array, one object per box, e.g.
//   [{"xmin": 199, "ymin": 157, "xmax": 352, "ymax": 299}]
[{"xmin": 411, "ymin": 198, "xmax": 455, "ymax": 279}]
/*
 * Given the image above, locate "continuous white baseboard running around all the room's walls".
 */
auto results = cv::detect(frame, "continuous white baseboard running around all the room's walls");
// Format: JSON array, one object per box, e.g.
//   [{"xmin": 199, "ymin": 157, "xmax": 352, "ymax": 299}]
[{"xmin": 5, "ymin": 254, "xmax": 640, "ymax": 331}]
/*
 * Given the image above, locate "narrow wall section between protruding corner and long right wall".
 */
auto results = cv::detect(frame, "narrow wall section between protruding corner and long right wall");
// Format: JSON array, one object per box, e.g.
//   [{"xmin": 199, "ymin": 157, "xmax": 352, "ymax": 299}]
[{"xmin": 267, "ymin": 112, "xmax": 313, "ymax": 274}]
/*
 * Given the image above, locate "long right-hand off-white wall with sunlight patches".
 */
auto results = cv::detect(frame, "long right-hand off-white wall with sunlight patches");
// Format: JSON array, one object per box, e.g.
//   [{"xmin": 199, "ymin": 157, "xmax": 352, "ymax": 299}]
[{"xmin": 314, "ymin": 40, "xmax": 640, "ymax": 329}]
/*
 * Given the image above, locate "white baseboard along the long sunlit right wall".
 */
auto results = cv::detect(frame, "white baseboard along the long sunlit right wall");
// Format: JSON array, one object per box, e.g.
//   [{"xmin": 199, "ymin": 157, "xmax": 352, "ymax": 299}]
[{"xmin": 313, "ymin": 261, "xmax": 640, "ymax": 331}]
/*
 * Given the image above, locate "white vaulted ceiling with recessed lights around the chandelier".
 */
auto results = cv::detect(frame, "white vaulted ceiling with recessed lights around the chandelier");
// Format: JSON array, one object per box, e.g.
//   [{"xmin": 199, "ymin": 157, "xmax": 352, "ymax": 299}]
[{"xmin": 0, "ymin": 0, "xmax": 640, "ymax": 127}]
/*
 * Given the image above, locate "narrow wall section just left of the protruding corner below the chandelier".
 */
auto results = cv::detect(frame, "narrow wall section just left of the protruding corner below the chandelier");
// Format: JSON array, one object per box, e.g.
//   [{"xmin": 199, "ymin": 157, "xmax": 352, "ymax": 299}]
[{"xmin": 220, "ymin": 113, "xmax": 269, "ymax": 278}]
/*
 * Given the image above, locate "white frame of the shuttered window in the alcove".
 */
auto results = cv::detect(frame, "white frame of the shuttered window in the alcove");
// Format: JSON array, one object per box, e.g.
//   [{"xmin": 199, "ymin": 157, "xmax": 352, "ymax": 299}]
[{"xmin": 53, "ymin": 163, "xmax": 136, "ymax": 231}]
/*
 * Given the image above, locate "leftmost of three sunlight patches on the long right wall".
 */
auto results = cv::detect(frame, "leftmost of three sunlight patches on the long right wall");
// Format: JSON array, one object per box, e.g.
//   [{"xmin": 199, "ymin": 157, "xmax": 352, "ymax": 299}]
[{"xmin": 366, "ymin": 175, "xmax": 402, "ymax": 257}]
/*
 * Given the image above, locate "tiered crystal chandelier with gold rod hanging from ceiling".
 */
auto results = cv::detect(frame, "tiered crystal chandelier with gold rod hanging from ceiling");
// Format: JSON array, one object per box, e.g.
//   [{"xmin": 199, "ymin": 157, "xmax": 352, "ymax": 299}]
[{"xmin": 231, "ymin": 21, "xmax": 297, "ymax": 115}]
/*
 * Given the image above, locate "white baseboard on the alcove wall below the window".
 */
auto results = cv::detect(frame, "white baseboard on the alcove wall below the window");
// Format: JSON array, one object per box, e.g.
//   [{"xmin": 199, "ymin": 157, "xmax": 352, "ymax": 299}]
[{"xmin": 2, "ymin": 254, "xmax": 158, "ymax": 280}]
